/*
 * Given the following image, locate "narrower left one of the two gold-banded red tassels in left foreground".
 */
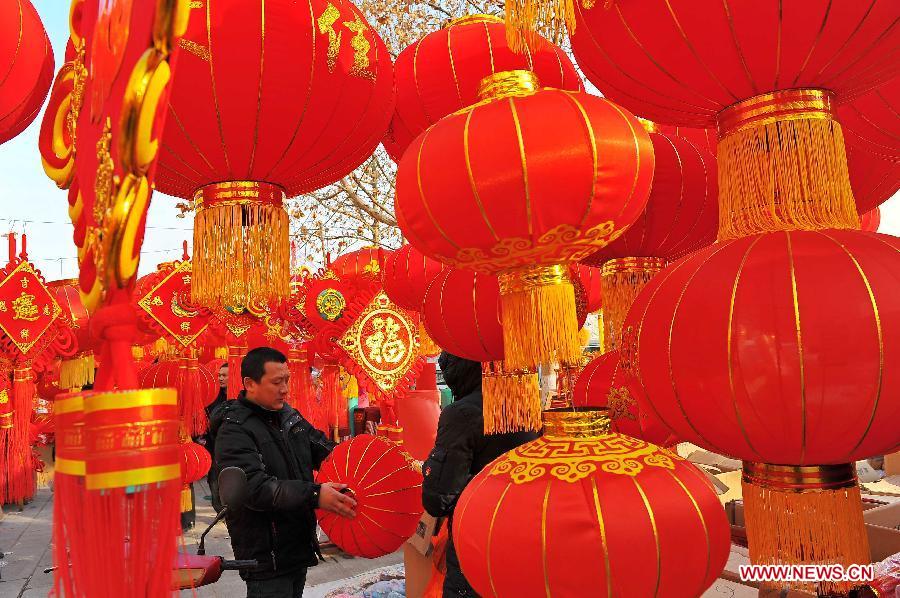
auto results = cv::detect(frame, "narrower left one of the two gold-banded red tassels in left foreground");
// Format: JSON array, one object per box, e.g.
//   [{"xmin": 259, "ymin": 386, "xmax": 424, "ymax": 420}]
[{"xmin": 53, "ymin": 393, "xmax": 90, "ymax": 598}]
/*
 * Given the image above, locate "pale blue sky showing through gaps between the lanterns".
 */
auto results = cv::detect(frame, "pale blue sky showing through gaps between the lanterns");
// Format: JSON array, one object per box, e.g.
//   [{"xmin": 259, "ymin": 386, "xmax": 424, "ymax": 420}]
[{"xmin": 0, "ymin": 0, "xmax": 900, "ymax": 280}]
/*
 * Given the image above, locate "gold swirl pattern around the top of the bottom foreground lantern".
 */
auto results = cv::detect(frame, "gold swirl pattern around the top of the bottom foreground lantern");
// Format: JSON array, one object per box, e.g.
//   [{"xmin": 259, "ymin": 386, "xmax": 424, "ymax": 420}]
[{"xmin": 490, "ymin": 434, "xmax": 675, "ymax": 484}]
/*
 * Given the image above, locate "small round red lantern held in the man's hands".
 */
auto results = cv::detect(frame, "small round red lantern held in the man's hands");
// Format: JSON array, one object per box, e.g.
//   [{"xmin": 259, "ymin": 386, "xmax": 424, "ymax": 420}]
[{"xmin": 316, "ymin": 434, "xmax": 422, "ymax": 558}]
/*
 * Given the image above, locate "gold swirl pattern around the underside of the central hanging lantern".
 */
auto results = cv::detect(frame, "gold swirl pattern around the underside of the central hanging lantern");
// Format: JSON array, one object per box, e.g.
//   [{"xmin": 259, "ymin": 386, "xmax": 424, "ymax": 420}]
[{"xmin": 435, "ymin": 220, "xmax": 624, "ymax": 273}]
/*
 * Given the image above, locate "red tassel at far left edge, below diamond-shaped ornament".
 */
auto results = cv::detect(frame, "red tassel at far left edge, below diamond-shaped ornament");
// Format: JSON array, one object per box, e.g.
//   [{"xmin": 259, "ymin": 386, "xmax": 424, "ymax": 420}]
[{"xmin": 3, "ymin": 364, "xmax": 35, "ymax": 505}]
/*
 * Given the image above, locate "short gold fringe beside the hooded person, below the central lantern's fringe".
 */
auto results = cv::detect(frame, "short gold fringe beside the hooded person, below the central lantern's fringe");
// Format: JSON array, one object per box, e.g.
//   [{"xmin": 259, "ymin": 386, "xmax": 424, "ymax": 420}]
[{"xmin": 481, "ymin": 361, "xmax": 541, "ymax": 434}]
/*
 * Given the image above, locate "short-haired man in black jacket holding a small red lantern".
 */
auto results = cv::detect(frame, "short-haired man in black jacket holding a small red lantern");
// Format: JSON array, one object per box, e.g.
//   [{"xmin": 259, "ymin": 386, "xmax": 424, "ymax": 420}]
[{"xmin": 215, "ymin": 347, "xmax": 356, "ymax": 598}]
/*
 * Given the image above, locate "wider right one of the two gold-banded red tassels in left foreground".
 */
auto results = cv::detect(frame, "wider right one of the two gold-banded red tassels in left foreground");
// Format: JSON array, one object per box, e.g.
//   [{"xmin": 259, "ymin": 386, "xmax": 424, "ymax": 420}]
[{"xmin": 81, "ymin": 388, "xmax": 182, "ymax": 596}]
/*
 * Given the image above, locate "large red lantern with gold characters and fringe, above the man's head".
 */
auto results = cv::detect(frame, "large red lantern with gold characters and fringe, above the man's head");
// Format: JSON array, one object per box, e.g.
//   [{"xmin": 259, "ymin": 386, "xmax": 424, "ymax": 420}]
[{"xmin": 157, "ymin": 0, "xmax": 394, "ymax": 306}]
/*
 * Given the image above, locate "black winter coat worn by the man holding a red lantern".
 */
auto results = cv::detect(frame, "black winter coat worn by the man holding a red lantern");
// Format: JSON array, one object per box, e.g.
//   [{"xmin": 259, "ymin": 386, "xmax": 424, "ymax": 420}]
[{"xmin": 213, "ymin": 393, "xmax": 335, "ymax": 580}]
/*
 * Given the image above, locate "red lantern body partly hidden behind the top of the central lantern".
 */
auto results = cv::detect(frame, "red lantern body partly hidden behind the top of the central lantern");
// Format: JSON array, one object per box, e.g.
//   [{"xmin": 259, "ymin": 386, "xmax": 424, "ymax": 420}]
[{"xmin": 384, "ymin": 15, "xmax": 582, "ymax": 161}]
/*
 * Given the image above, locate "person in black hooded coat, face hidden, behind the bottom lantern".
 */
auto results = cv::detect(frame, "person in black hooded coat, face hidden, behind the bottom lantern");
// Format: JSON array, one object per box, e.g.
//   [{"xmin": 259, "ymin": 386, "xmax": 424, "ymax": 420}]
[{"xmin": 422, "ymin": 352, "xmax": 538, "ymax": 598}]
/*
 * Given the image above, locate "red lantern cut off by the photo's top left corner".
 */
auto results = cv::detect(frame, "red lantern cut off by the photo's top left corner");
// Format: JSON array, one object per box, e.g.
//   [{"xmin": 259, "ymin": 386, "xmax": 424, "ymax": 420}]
[{"xmin": 0, "ymin": 0, "xmax": 54, "ymax": 143}]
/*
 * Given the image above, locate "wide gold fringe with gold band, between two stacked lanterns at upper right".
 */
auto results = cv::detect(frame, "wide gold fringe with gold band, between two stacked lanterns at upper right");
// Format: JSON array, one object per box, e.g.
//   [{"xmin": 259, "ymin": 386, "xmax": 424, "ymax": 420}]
[{"xmin": 717, "ymin": 89, "xmax": 859, "ymax": 241}]
